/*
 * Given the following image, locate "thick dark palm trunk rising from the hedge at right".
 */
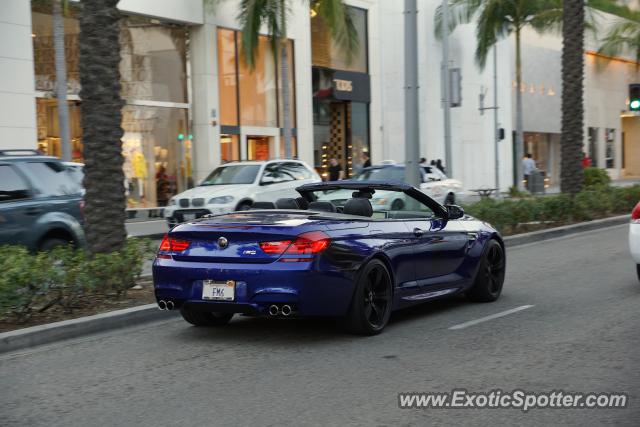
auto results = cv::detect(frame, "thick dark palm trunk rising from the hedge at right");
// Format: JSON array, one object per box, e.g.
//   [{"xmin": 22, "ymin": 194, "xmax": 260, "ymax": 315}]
[{"xmin": 560, "ymin": 0, "xmax": 585, "ymax": 194}]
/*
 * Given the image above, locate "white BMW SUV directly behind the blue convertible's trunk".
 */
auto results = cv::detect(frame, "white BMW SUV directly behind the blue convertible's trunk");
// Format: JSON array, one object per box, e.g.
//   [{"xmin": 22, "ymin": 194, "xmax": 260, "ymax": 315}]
[{"xmin": 164, "ymin": 160, "xmax": 321, "ymax": 227}]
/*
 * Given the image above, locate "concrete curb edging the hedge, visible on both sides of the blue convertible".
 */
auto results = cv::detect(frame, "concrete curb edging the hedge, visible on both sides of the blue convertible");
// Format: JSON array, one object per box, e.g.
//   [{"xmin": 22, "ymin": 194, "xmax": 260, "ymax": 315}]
[{"xmin": 0, "ymin": 215, "xmax": 630, "ymax": 354}]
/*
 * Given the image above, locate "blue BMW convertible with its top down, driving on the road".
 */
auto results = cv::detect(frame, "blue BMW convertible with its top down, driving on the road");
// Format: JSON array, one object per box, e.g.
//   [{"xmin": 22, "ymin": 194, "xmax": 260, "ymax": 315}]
[{"xmin": 153, "ymin": 181, "xmax": 506, "ymax": 334}]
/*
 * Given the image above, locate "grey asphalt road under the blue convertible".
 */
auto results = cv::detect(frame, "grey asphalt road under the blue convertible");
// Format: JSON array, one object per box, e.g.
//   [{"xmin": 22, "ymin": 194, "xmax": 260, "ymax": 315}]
[{"xmin": 0, "ymin": 226, "xmax": 640, "ymax": 426}]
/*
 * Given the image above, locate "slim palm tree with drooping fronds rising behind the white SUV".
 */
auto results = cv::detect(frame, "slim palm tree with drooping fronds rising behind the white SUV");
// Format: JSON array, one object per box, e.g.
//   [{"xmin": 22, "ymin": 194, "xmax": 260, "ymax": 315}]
[{"xmin": 239, "ymin": 0, "xmax": 358, "ymax": 158}]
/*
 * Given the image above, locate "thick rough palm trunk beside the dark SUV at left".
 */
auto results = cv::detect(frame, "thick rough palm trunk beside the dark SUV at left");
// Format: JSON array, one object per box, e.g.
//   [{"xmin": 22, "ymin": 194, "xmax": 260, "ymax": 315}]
[{"xmin": 79, "ymin": 0, "xmax": 127, "ymax": 253}]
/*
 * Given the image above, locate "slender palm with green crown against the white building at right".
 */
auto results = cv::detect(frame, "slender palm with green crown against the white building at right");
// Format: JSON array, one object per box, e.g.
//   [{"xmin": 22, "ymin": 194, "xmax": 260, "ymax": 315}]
[{"xmin": 434, "ymin": 0, "xmax": 562, "ymax": 191}]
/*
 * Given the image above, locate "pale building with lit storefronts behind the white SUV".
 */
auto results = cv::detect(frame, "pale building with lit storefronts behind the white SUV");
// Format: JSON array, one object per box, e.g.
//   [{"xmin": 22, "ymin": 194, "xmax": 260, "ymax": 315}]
[{"xmin": 0, "ymin": 0, "xmax": 380, "ymax": 208}]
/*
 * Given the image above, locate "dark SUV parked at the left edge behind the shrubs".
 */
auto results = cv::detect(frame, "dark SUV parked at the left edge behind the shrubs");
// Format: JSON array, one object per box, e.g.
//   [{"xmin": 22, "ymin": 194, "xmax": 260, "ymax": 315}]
[{"xmin": 0, "ymin": 150, "xmax": 85, "ymax": 251}]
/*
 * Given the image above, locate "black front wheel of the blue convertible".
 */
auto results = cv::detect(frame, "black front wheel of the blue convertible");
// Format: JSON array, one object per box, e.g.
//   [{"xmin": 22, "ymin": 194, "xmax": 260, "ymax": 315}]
[{"xmin": 466, "ymin": 239, "xmax": 506, "ymax": 302}]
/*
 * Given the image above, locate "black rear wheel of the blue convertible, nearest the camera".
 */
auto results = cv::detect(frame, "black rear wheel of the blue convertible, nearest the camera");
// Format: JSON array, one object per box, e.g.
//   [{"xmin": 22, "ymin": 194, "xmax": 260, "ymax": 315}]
[{"xmin": 346, "ymin": 259, "xmax": 393, "ymax": 335}]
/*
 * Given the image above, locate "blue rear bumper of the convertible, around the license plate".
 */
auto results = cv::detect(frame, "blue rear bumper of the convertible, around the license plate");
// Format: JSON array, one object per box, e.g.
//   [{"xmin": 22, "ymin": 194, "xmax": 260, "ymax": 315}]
[{"xmin": 153, "ymin": 259, "xmax": 354, "ymax": 316}]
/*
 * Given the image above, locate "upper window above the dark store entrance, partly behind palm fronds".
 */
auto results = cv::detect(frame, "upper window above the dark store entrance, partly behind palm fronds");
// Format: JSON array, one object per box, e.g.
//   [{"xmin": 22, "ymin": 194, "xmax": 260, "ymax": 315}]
[{"xmin": 311, "ymin": 7, "xmax": 368, "ymax": 73}]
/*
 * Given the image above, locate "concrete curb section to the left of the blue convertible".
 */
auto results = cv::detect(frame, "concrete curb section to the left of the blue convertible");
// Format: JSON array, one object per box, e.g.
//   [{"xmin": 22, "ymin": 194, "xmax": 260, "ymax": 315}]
[{"xmin": 0, "ymin": 304, "xmax": 176, "ymax": 354}]
